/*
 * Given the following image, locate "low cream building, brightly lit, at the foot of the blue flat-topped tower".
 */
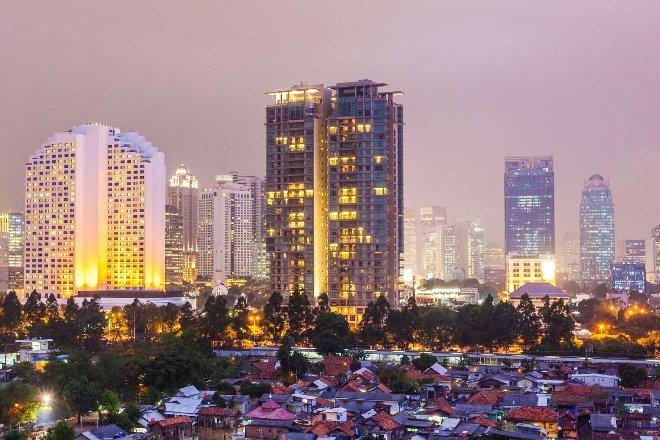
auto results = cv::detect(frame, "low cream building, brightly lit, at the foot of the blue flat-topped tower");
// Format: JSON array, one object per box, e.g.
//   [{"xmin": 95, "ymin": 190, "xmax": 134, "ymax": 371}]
[{"xmin": 506, "ymin": 255, "xmax": 557, "ymax": 292}]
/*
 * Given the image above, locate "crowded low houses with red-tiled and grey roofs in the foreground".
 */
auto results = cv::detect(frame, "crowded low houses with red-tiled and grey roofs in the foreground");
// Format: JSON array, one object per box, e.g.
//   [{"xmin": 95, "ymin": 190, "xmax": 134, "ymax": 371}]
[{"xmin": 80, "ymin": 356, "xmax": 660, "ymax": 440}]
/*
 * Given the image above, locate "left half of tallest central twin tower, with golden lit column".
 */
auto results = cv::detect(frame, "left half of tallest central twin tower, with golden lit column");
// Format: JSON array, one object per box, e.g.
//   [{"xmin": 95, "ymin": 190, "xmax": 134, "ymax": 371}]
[{"xmin": 266, "ymin": 85, "xmax": 331, "ymax": 303}]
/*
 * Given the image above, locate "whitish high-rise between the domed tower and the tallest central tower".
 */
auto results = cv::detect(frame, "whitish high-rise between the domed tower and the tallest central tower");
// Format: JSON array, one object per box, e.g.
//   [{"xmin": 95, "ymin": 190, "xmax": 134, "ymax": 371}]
[{"xmin": 198, "ymin": 176, "xmax": 255, "ymax": 285}]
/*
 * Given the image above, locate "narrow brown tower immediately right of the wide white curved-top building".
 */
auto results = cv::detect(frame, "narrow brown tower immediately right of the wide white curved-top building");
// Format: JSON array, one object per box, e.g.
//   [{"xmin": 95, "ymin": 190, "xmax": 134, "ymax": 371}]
[{"xmin": 165, "ymin": 205, "xmax": 183, "ymax": 290}]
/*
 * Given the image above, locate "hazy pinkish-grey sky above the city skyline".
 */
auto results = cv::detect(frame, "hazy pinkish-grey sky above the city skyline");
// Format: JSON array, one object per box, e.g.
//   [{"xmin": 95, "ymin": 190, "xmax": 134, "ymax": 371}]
[{"xmin": 0, "ymin": 0, "xmax": 660, "ymax": 248}]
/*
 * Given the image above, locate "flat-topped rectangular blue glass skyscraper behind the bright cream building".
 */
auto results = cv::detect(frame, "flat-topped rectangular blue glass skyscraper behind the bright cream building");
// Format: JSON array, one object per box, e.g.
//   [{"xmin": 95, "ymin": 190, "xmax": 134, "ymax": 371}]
[{"xmin": 504, "ymin": 156, "xmax": 555, "ymax": 257}]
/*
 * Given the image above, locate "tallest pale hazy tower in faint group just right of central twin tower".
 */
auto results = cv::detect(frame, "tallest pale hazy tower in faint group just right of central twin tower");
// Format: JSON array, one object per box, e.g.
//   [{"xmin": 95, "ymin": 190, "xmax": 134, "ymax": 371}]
[{"xmin": 418, "ymin": 206, "xmax": 447, "ymax": 278}]
